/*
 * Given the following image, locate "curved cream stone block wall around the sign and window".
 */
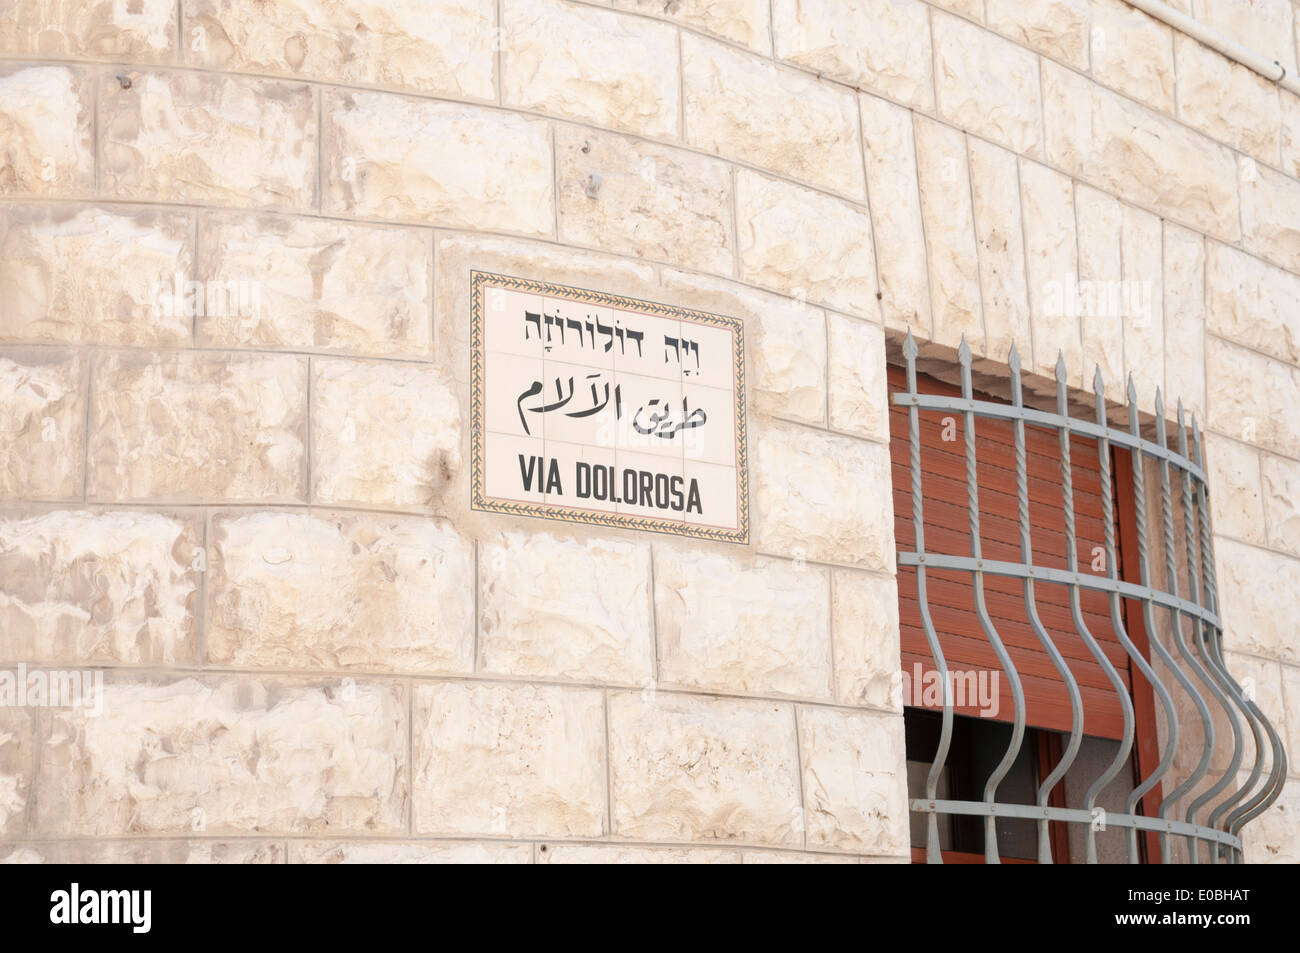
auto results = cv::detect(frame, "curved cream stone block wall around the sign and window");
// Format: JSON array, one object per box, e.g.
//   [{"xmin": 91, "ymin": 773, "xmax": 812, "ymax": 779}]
[{"xmin": 0, "ymin": 0, "xmax": 1300, "ymax": 862}]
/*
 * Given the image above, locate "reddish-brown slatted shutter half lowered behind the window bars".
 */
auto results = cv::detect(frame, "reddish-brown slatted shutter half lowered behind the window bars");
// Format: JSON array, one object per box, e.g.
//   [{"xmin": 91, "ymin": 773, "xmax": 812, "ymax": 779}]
[{"xmin": 889, "ymin": 367, "xmax": 1131, "ymax": 738}]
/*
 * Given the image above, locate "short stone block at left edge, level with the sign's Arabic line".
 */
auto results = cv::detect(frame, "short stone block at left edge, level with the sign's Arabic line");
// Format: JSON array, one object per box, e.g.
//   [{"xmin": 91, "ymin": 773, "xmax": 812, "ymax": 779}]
[{"xmin": 0, "ymin": 350, "xmax": 87, "ymax": 499}]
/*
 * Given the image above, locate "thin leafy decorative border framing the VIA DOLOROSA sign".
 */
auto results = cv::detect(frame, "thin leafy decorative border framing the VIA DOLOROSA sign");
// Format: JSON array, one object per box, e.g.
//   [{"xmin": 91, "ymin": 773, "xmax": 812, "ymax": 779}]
[{"xmin": 469, "ymin": 269, "xmax": 749, "ymax": 543}]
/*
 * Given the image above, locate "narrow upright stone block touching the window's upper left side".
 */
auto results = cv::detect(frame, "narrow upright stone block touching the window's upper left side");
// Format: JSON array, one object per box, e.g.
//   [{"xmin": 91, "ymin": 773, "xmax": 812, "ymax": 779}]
[{"xmin": 827, "ymin": 315, "xmax": 889, "ymax": 443}]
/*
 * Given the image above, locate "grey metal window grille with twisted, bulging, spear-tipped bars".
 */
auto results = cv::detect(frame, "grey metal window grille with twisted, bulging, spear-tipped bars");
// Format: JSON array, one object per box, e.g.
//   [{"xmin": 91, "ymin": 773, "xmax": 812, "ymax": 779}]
[{"xmin": 892, "ymin": 332, "xmax": 1287, "ymax": 863}]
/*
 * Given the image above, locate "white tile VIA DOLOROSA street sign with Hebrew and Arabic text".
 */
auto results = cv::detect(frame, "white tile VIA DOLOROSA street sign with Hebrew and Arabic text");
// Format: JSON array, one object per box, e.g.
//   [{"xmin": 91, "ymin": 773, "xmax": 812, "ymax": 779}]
[{"xmin": 471, "ymin": 272, "xmax": 749, "ymax": 542}]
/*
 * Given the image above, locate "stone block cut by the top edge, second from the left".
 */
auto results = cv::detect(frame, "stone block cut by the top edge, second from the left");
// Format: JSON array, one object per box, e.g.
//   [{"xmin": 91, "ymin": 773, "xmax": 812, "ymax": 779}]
[{"xmin": 183, "ymin": 0, "xmax": 497, "ymax": 100}]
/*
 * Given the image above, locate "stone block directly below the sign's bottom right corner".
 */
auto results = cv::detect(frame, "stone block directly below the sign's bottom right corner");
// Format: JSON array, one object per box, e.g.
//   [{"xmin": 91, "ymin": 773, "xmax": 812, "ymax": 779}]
[{"xmin": 655, "ymin": 546, "xmax": 831, "ymax": 698}]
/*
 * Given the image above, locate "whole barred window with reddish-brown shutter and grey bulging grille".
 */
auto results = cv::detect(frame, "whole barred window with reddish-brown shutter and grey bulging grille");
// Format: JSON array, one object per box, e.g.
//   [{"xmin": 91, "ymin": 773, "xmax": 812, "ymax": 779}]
[{"xmin": 888, "ymin": 335, "xmax": 1286, "ymax": 862}]
